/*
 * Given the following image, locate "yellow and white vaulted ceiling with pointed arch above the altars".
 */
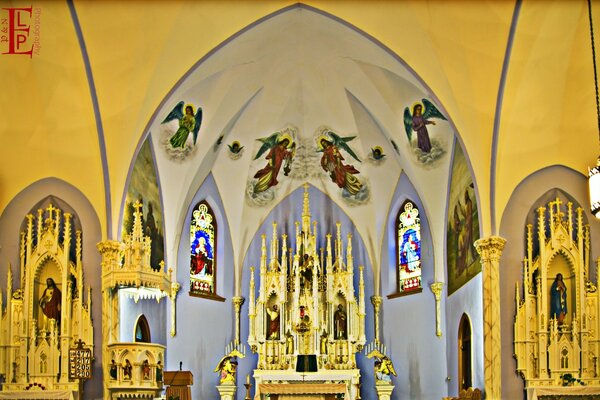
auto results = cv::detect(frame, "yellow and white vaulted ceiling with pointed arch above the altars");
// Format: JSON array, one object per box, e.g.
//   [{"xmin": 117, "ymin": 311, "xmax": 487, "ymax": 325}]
[{"xmin": 0, "ymin": 1, "xmax": 600, "ymax": 268}]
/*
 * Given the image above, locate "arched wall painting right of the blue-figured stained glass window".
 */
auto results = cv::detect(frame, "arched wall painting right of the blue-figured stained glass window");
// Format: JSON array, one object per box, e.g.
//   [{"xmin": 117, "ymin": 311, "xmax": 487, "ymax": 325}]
[{"xmin": 446, "ymin": 144, "xmax": 481, "ymax": 295}]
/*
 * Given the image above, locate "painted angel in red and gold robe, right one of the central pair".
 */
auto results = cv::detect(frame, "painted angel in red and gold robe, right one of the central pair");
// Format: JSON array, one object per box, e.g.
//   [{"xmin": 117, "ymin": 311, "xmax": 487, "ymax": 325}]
[{"xmin": 318, "ymin": 131, "xmax": 362, "ymax": 195}]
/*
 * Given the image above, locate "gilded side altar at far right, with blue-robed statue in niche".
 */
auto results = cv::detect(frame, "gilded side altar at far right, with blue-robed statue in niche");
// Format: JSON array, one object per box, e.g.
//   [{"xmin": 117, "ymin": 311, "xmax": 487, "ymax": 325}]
[{"xmin": 514, "ymin": 198, "xmax": 600, "ymax": 395}]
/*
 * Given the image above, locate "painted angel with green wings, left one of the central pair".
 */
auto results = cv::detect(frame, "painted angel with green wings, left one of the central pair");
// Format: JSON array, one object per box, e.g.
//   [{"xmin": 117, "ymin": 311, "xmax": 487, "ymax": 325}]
[{"xmin": 253, "ymin": 132, "xmax": 296, "ymax": 195}]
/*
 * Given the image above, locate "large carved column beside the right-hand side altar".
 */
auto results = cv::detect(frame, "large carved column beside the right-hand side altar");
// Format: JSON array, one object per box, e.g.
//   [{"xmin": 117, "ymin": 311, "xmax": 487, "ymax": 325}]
[{"xmin": 475, "ymin": 236, "xmax": 506, "ymax": 399}]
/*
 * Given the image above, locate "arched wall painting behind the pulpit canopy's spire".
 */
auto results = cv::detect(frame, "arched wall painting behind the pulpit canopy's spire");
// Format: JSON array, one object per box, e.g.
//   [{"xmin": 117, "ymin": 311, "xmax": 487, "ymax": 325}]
[{"xmin": 121, "ymin": 139, "xmax": 165, "ymax": 269}]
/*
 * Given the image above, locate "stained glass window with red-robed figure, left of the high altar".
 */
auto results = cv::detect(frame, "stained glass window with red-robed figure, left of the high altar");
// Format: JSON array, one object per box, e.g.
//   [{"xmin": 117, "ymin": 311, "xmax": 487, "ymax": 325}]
[{"xmin": 190, "ymin": 201, "xmax": 217, "ymax": 297}]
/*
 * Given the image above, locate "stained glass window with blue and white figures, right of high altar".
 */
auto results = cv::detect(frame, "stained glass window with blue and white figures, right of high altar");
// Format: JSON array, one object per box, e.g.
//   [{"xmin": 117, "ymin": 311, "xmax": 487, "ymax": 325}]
[{"xmin": 396, "ymin": 200, "xmax": 422, "ymax": 294}]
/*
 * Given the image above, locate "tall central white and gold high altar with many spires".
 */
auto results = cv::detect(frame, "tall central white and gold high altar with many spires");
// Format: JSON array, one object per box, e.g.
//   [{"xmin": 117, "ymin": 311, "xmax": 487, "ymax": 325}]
[{"xmin": 248, "ymin": 185, "xmax": 366, "ymax": 399}]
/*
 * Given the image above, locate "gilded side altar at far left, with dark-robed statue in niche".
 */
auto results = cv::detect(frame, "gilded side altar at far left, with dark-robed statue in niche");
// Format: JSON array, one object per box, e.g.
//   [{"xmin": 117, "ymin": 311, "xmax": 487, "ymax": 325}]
[{"xmin": 0, "ymin": 204, "xmax": 94, "ymax": 399}]
